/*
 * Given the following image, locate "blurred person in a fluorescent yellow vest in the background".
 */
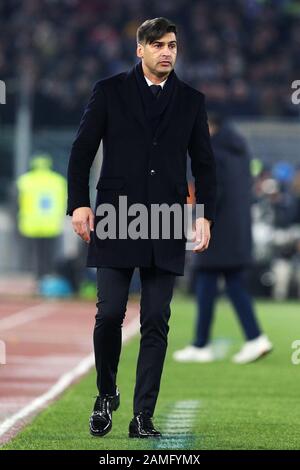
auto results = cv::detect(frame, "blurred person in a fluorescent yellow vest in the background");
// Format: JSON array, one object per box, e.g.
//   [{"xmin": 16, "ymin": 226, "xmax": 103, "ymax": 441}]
[{"xmin": 16, "ymin": 154, "xmax": 67, "ymax": 281}]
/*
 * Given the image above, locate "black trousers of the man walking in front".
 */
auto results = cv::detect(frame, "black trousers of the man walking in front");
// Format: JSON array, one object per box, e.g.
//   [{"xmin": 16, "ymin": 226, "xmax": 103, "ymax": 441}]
[{"xmin": 94, "ymin": 258, "xmax": 176, "ymax": 416}]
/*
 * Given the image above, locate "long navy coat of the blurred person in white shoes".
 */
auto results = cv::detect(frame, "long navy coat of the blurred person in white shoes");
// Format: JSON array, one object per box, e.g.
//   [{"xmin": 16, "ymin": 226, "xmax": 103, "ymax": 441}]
[{"xmin": 194, "ymin": 115, "xmax": 252, "ymax": 269}]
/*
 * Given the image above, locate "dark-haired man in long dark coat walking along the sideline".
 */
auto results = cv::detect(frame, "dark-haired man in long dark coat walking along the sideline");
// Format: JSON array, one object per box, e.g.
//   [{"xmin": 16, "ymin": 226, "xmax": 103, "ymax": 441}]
[{"xmin": 67, "ymin": 18, "xmax": 216, "ymax": 437}]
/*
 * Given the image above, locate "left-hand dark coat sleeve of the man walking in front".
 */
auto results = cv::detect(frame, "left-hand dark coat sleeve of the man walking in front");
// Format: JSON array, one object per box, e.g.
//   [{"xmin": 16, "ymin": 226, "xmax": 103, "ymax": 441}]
[{"xmin": 66, "ymin": 81, "xmax": 107, "ymax": 215}]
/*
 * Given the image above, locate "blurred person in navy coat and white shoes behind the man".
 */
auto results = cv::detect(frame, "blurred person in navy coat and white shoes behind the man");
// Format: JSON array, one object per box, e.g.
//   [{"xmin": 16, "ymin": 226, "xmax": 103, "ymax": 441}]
[{"xmin": 173, "ymin": 114, "xmax": 272, "ymax": 364}]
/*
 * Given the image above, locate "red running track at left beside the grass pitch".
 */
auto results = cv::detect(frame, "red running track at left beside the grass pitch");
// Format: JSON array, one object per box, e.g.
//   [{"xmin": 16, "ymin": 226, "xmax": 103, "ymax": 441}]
[{"xmin": 0, "ymin": 298, "xmax": 139, "ymax": 445}]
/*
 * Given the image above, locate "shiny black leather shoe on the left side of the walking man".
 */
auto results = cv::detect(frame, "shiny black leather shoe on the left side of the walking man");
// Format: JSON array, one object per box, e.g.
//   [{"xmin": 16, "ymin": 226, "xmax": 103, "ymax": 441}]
[{"xmin": 90, "ymin": 387, "xmax": 120, "ymax": 436}]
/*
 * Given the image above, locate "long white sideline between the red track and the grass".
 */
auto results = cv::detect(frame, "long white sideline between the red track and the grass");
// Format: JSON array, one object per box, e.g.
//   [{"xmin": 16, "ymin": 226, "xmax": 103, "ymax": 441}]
[{"xmin": 0, "ymin": 317, "xmax": 140, "ymax": 437}]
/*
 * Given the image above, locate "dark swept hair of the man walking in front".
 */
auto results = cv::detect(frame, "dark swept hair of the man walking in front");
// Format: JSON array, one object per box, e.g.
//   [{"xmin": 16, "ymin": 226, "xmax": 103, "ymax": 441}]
[{"xmin": 136, "ymin": 17, "xmax": 177, "ymax": 44}]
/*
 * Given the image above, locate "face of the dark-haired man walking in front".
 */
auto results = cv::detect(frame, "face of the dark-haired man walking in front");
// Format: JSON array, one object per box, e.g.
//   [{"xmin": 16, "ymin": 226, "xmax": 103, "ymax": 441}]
[{"xmin": 137, "ymin": 33, "xmax": 177, "ymax": 77}]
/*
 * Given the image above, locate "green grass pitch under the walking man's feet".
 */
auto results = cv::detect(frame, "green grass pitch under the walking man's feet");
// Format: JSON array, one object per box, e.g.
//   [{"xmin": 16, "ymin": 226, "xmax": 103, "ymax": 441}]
[{"xmin": 3, "ymin": 296, "xmax": 300, "ymax": 450}]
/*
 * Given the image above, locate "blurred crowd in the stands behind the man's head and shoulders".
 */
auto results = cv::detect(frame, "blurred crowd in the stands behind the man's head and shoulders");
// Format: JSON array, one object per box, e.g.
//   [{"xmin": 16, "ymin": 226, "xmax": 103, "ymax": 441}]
[{"xmin": 0, "ymin": 0, "xmax": 300, "ymax": 126}]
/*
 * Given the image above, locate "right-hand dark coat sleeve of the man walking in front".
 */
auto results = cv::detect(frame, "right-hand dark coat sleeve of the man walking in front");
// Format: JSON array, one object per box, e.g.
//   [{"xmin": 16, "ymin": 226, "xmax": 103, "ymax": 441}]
[{"xmin": 188, "ymin": 94, "xmax": 217, "ymax": 225}]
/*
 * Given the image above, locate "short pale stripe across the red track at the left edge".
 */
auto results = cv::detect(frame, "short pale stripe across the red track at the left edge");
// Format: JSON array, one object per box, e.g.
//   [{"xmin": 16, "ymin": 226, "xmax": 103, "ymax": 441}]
[{"xmin": 0, "ymin": 302, "xmax": 58, "ymax": 332}]
